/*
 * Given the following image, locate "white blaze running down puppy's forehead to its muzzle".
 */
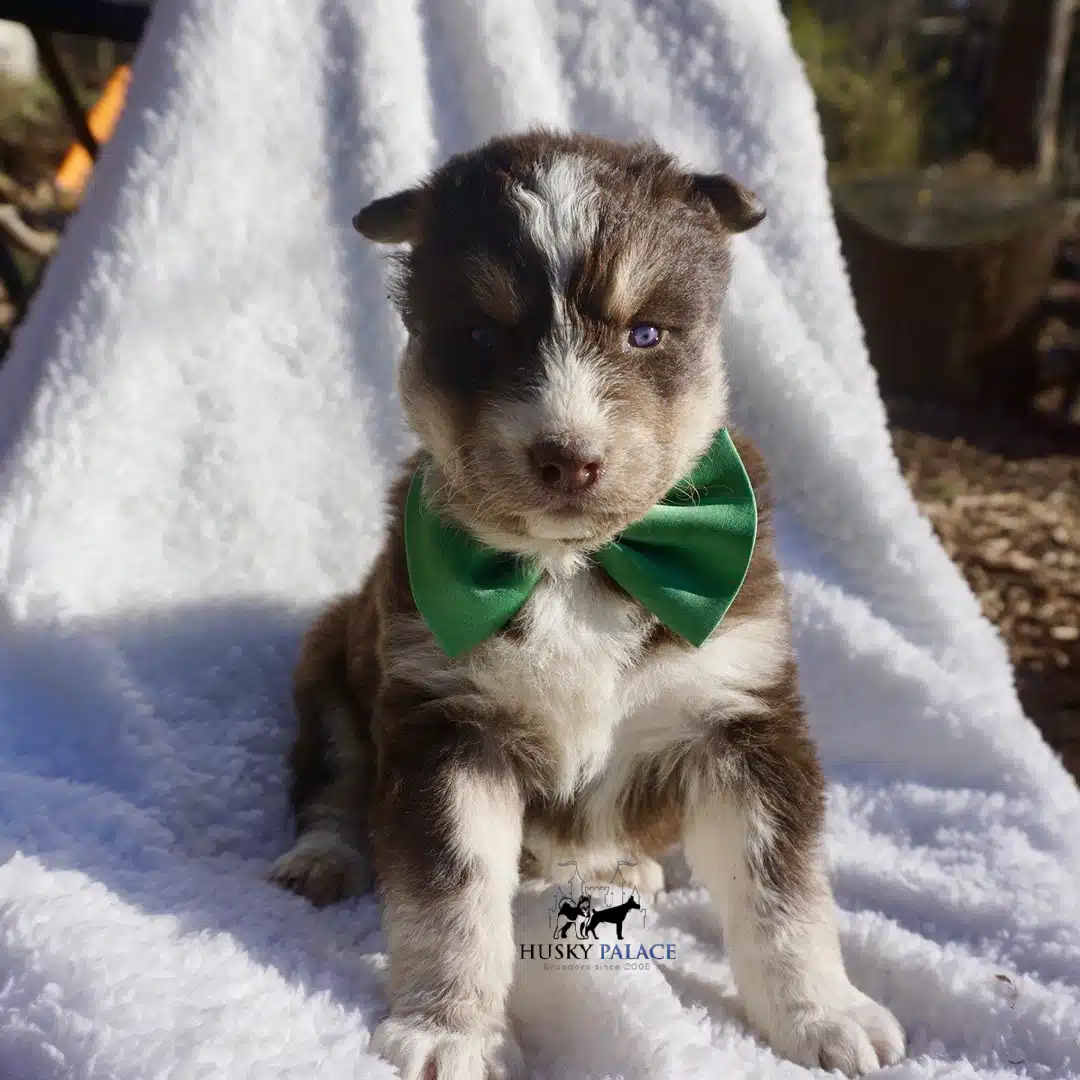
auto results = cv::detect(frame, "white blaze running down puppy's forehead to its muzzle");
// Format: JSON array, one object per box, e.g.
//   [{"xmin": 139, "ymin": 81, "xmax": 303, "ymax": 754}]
[{"xmin": 513, "ymin": 153, "xmax": 607, "ymax": 453}]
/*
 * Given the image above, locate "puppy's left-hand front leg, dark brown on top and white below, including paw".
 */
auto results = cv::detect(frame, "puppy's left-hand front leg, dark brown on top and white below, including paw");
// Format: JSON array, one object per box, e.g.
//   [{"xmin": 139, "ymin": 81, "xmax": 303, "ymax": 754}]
[{"xmin": 373, "ymin": 694, "xmax": 523, "ymax": 1080}]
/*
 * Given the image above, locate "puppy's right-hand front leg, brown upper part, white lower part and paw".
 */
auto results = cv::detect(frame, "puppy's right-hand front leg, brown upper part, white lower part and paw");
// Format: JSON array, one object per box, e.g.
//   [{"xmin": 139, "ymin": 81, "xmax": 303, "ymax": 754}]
[{"xmin": 685, "ymin": 692, "xmax": 904, "ymax": 1077}]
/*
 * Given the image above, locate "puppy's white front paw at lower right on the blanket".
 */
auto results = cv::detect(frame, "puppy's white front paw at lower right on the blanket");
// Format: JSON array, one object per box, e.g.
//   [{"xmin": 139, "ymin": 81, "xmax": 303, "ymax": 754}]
[{"xmin": 771, "ymin": 987, "xmax": 905, "ymax": 1077}]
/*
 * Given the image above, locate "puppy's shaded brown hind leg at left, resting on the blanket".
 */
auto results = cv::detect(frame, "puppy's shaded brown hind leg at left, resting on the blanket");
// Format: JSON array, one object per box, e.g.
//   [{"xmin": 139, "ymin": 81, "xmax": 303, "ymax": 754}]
[{"xmin": 269, "ymin": 595, "xmax": 375, "ymax": 907}]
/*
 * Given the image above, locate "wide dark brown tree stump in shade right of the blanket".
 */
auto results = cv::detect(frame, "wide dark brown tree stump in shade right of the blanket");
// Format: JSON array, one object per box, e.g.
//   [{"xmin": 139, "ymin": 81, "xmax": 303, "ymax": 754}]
[{"xmin": 833, "ymin": 174, "xmax": 1062, "ymax": 409}]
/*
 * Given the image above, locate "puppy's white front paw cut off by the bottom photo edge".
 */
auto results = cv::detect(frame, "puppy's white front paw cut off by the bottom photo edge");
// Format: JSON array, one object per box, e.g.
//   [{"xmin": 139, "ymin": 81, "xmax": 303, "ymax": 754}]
[{"xmin": 372, "ymin": 1016, "xmax": 525, "ymax": 1080}]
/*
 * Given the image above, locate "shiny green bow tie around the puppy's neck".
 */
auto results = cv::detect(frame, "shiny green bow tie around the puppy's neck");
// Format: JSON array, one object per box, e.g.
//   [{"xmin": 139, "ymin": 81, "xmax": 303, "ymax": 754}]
[{"xmin": 405, "ymin": 428, "xmax": 757, "ymax": 657}]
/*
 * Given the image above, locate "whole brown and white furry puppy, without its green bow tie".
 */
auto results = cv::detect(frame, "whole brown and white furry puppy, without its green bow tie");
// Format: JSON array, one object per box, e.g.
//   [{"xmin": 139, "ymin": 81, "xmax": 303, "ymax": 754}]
[{"xmin": 267, "ymin": 132, "xmax": 904, "ymax": 1080}]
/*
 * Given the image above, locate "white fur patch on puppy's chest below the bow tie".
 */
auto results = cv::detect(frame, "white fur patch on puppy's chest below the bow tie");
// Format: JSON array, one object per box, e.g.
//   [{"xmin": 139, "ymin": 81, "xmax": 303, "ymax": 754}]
[{"xmin": 471, "ymin": 572, "xmax": 788, "ymax": 801}]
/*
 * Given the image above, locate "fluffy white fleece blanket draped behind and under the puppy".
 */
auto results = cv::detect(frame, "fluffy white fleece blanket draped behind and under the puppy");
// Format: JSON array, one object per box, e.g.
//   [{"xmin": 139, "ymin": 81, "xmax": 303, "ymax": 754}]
[{"xmin": 0, "ymin": 0, "xmax": 1080, "ymax": 1080}]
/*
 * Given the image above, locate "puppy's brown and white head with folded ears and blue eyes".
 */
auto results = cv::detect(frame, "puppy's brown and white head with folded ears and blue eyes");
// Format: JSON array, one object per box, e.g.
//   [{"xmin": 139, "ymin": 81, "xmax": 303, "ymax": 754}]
[{"xmin": 354, "ymin": 133, "xmax": 764, "ymax": 553}]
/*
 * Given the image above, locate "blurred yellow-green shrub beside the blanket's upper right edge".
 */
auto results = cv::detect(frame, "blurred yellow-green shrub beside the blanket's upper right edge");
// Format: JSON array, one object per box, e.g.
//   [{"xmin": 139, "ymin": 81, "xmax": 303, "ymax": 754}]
[{"xmin": 788, "ymin": 0, "xmax": 931, "ymax": 173}]
